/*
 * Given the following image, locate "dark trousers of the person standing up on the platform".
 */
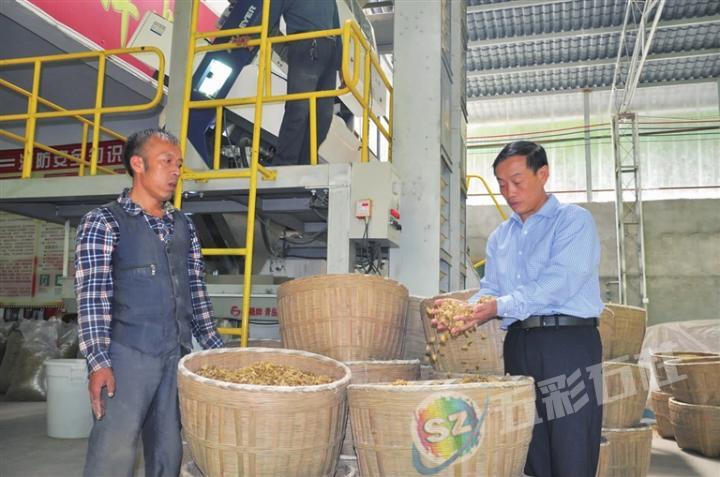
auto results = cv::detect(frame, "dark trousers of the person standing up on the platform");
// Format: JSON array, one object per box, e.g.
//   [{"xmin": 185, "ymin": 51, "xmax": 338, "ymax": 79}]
[{"xmin": 272, "ymin": 38, "xmax": 338, "ymax": 166}]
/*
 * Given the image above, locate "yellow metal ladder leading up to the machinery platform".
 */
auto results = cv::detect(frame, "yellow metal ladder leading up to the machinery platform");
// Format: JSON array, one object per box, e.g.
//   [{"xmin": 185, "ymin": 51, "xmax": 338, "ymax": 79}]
[{"xmin": 175, "ymin": 0, "xmax": 276, "ymax": 347}]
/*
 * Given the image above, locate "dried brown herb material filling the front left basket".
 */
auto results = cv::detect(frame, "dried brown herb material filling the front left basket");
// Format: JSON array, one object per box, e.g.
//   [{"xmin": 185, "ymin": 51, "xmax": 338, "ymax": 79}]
[{"xmin": 196, "ymin": 361, "xmax": 333, "ymax": 386}]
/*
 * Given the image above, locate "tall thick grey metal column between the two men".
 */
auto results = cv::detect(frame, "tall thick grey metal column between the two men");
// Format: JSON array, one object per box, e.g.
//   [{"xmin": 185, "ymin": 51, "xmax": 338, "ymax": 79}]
[{"xmin": 390, "ymin": 0, "xmax": 465, "ymax": 296}]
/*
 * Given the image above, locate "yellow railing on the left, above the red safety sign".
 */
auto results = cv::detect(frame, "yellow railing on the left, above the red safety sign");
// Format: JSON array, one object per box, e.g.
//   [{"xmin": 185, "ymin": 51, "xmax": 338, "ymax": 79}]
[{"xmin": 0, "ymin": 47, "xmax": 165, "ymax": 179}]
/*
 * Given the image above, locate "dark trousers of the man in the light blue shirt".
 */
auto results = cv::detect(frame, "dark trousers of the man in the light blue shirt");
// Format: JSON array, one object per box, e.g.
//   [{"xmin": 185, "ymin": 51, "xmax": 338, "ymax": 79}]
[{"xmin": 504, "ymin": 326, "xmax": 602, "ymax": 477}]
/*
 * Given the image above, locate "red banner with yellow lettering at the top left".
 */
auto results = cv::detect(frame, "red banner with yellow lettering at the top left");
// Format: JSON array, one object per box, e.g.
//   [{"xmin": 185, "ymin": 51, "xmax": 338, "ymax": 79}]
[{"xmin": 28, "ymin": 0, "xmax": 218, "ymax": 73}]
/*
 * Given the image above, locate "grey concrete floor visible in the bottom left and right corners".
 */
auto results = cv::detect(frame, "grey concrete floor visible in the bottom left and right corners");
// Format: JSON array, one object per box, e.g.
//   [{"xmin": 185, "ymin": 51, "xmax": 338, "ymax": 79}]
[{"xmin": 0, "ymin": 396, "xmax": 720, "ymax": 477}]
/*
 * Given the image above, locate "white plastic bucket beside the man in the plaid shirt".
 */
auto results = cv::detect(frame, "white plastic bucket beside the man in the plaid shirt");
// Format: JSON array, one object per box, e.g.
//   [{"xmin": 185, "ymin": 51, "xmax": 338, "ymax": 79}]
[{"xmin": 45, "ymin": 359, "xmax": 93, "ymax": 439}]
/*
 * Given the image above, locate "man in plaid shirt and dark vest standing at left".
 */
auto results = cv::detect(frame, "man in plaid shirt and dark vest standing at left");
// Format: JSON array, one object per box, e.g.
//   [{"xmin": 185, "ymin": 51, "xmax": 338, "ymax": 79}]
[{"xmin": 75, "ymin": 129, "xmax": 223, "ymax": 477}]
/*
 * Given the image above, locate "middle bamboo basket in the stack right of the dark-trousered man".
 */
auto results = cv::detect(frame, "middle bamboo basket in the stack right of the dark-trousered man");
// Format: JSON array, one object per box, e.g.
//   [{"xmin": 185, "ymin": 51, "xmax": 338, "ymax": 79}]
[{"xmin": 602, "ymin": 361, "xmax": 649, "ymax": 428}]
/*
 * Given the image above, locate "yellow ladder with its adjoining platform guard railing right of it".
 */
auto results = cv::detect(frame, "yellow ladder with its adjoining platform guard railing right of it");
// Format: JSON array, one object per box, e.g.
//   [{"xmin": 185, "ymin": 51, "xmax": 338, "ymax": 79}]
[{"xmin": 175, "ymin": 0, "xmax": 393, "ymax": 346}]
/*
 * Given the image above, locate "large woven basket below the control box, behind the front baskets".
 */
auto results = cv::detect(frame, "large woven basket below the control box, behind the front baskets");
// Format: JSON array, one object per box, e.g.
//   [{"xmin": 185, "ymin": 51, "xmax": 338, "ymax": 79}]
[{"xmin": 277, "ymin": 274, "xmax": 408, "ymax": 361}]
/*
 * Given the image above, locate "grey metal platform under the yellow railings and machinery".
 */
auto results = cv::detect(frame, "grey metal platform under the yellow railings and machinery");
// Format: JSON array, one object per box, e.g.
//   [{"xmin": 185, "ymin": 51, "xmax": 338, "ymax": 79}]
[{"xmin": 0, "ymin": 164, "xmax": 353, "ymax": 273}]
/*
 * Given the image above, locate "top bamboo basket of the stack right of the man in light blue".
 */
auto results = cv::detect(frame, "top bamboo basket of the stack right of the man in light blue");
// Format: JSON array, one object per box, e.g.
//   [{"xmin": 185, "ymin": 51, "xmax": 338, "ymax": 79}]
[{"xmin": 605, "ymin": 303, "xmax": 647, "ymax": 363}]
